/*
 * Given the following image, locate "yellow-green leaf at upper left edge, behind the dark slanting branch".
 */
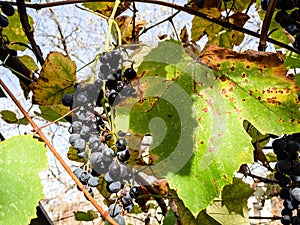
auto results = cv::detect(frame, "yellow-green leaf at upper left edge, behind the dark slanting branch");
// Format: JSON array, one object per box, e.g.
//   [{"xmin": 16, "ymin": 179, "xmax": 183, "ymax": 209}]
[{"xmin": 2, "ymin": 11, "xmax": 33, "ymax": 51}]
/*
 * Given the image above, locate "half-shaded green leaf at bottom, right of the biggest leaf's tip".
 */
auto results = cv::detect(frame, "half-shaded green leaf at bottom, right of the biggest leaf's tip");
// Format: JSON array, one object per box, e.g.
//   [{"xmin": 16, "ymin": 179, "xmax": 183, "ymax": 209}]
[{"xmin": 206, "ymin": 178, "xmax": 253, "ymax": 225}]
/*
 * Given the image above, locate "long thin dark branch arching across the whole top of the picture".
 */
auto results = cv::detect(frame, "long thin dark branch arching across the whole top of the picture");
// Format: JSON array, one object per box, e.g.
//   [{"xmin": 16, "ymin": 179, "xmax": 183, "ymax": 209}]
[{"xmin": 11, "ymin": 0, "xmax": 300, "ymax": 54}]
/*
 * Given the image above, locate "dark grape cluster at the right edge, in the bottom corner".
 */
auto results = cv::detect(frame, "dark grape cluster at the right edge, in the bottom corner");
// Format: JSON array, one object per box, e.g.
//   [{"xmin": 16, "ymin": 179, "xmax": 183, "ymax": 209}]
[{"xmin": 272, "ymin": 133, "xmax": 300, "ymax": 225}]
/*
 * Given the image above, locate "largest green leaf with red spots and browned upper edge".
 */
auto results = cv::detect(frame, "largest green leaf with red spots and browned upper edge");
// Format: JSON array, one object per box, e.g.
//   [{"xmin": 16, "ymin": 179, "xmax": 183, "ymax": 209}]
[{"xmin": 128, "ymin": 42, "xmax": 300, "ymax": 216}]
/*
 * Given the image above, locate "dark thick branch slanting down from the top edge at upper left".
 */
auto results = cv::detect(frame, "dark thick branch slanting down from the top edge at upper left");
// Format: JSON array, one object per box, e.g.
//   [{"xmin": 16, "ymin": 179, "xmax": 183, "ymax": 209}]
[{"xmin": 17, "ymin": 0, "xmax": 45, "ymax": 65}]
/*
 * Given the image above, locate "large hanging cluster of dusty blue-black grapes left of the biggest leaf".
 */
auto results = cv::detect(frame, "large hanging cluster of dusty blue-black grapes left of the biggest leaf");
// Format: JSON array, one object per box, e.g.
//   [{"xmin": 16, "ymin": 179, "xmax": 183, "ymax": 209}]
[{"xmin": 62, "ymin": 50, "xmax": 144, "ymax": 224}]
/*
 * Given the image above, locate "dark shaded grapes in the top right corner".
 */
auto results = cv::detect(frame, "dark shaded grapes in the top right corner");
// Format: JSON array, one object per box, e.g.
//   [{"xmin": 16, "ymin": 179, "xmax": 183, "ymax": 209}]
[{"xmin": 261, "ymin": 0, "xmax": 300, "ymax": 50}]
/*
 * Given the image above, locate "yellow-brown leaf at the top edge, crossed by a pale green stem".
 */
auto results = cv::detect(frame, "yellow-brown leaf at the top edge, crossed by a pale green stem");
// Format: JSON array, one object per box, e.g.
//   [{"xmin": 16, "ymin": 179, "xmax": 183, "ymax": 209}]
[{"xmin": 82, "ymin": 2, "xmax": 131, "ymax": 17}]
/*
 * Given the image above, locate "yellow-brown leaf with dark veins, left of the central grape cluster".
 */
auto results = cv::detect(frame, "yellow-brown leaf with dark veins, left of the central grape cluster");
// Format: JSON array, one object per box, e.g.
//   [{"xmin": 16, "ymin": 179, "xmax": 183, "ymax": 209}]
[{"xmin": 30, "ymin": 52, "xmax": 76, "ymax": 120}]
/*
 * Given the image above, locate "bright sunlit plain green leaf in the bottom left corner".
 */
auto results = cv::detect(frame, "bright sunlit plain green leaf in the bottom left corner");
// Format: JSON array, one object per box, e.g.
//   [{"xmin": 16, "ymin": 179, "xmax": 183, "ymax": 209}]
[{"xmin": 0, "ymin": 136, "xmax": 47, "ymax": 225}]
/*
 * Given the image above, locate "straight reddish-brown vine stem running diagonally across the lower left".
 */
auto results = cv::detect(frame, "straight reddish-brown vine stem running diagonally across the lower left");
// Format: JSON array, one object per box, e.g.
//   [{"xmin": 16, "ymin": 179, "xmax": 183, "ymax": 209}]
[{"xmin": 0, "ymin": 79, "xmax": 118, "ymax": 225}]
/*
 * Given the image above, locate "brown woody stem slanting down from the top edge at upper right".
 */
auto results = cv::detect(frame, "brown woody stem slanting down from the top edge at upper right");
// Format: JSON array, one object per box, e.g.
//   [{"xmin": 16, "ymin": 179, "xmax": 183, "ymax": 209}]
[{"xmin": 258, "ymin": 0, "xmax": 277, "ymax": 51}]
